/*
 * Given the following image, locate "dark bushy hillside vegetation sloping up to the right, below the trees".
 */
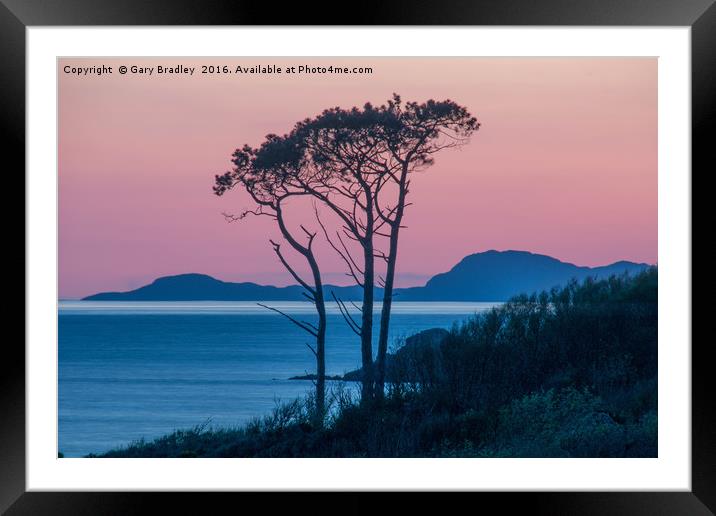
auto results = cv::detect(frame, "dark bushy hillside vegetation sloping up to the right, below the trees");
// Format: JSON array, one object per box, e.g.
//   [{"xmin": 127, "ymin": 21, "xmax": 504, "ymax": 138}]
[{"xmin": 90, "ymin": 268, "xmax": 657, "ymax": 457}]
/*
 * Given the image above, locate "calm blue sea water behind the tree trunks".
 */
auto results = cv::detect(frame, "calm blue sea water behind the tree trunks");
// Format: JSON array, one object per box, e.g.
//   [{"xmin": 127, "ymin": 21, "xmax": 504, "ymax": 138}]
[{"xmin": 58, "ymin": 301, "xmax": 494, "ymax": 457}]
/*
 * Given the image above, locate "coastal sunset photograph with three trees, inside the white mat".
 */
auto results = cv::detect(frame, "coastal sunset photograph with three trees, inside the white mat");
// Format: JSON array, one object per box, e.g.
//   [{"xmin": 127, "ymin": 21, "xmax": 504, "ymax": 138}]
[{"xmin": 58, "ymin": 56, "xmax": 656, "ymax": 459}]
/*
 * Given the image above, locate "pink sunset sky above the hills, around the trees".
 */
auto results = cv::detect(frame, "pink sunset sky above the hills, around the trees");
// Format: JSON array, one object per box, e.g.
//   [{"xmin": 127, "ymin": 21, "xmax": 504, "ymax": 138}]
[{"xmin": 59, "ymin": 58, "xmax": 657, "ymax": 298}]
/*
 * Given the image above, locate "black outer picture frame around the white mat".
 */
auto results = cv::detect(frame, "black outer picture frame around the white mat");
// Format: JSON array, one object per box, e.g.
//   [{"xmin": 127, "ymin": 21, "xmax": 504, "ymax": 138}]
[{"xmin": 0, "ymin": 0, "xmax": 716, "ymax": 515}]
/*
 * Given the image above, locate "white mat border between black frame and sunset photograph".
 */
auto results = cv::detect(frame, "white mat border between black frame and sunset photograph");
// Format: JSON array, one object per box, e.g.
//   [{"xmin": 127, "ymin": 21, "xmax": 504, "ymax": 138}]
[{"xmin": 26, "ymin": 27, "xmax": 691, "ymax": 491}]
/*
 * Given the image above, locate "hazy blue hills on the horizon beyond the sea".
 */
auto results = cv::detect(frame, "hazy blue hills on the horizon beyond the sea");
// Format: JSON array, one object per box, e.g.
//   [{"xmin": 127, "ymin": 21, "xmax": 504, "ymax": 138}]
[{"xmin": 83, "ymin": 250, "xmax": 649, "ymax": 302}]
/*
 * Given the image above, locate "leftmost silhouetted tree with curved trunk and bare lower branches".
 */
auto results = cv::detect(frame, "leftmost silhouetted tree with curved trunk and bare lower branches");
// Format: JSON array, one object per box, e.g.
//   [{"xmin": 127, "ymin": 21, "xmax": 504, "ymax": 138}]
[{"xmin": 214, "ymin": 135, "xmax": 326, "ymax": 426}]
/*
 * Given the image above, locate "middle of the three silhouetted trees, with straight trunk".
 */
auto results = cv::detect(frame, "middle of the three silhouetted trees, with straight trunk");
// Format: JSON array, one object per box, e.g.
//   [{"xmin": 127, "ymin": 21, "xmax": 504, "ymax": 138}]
[{"xmin": 290, "ymin": 104, "xmax": 396, "ymax": 403}]
